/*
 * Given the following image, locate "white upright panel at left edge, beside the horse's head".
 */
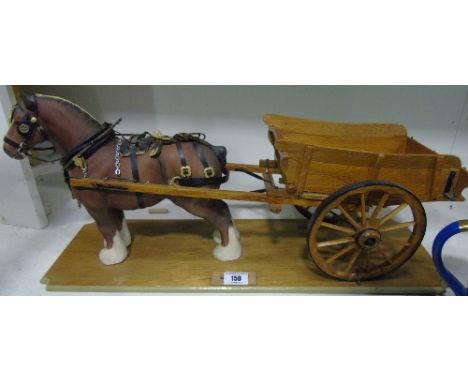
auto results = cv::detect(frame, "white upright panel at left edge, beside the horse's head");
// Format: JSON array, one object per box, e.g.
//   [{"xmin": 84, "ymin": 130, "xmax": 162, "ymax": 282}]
[{"xmin": 0, "ymin": 86, "xmax": 47, "ymax": 228}]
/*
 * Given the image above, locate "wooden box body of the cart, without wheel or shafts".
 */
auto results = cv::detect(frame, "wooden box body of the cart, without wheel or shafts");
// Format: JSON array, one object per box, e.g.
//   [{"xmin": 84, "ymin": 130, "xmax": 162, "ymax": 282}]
[{"xmin": 264, "ymin": 115, "xmax": 468, "ymax": 202}]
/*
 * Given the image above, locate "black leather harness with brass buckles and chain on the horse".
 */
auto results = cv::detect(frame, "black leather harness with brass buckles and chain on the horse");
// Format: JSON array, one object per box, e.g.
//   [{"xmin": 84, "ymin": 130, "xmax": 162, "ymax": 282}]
[{"xmin": 3, "ymin": 102, "xmax": 229, "ymax": 208}]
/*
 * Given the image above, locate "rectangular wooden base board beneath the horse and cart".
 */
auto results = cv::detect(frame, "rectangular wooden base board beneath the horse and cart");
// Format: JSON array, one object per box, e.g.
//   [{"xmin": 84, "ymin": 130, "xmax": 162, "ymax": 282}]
[{"xmin": 41, "ymin": 220, "xmax": 445, "ymax": 295}]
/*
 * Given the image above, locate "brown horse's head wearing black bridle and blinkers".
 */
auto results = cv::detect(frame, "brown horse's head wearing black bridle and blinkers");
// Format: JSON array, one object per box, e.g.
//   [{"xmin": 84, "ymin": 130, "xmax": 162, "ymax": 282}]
[{"xmin": 3, "ymin": 95, "xmax": 47, "ymax": 159}]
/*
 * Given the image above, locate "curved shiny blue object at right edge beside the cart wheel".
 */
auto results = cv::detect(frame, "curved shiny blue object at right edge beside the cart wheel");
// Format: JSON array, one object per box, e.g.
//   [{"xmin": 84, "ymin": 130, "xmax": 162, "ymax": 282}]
[{"xmin": 432, "ymin": 220, "xmax": 468, "ymax": 296}]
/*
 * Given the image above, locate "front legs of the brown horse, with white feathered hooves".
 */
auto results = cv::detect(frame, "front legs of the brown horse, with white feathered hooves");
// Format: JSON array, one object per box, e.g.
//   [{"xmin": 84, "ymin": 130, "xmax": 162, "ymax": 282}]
[{"xmin": 85, "ymin": 206, "xmax": 131, "ymax": 265}]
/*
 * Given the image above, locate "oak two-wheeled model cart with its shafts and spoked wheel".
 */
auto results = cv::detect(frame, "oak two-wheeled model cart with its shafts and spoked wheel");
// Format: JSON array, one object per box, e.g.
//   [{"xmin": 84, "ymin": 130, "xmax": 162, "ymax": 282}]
[{"xmin": 70, "ymin": 115, "xmax": 468, "ymax": 281}]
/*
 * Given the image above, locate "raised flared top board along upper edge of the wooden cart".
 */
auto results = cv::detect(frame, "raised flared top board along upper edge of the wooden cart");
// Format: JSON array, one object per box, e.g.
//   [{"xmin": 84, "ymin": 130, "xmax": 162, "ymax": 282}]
[{"xmin": 264, "ymin": 115, "xmax": 407, "ymax": 153}]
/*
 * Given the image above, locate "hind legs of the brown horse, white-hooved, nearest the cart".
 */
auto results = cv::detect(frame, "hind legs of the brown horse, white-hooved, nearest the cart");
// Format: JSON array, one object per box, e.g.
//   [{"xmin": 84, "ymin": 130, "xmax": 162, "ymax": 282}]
[{"xmin": 171, "ymin": 198, "xmax": 242, "ymax": 261}]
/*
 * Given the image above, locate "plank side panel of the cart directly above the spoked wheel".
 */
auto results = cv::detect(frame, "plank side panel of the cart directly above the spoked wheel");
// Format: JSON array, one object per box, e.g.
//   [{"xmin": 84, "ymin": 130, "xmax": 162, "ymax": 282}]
[{"xmin": 282, "ymin": 145, "xmax": 461, "ymax": 201}]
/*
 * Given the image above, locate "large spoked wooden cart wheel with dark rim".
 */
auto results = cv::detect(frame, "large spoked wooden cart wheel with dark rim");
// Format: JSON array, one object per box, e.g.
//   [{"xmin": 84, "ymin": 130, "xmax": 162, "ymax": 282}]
[{"xmin": 308, "ymin": 180, "xmax": 426, "ymax": 281}]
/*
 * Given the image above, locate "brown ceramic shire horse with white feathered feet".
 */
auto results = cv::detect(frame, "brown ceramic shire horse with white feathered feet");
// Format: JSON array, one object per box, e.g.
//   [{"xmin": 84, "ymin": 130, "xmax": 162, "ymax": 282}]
[{"xmin": 3, "ymin": 95, "xmax": 242, "ymax": 265}]
